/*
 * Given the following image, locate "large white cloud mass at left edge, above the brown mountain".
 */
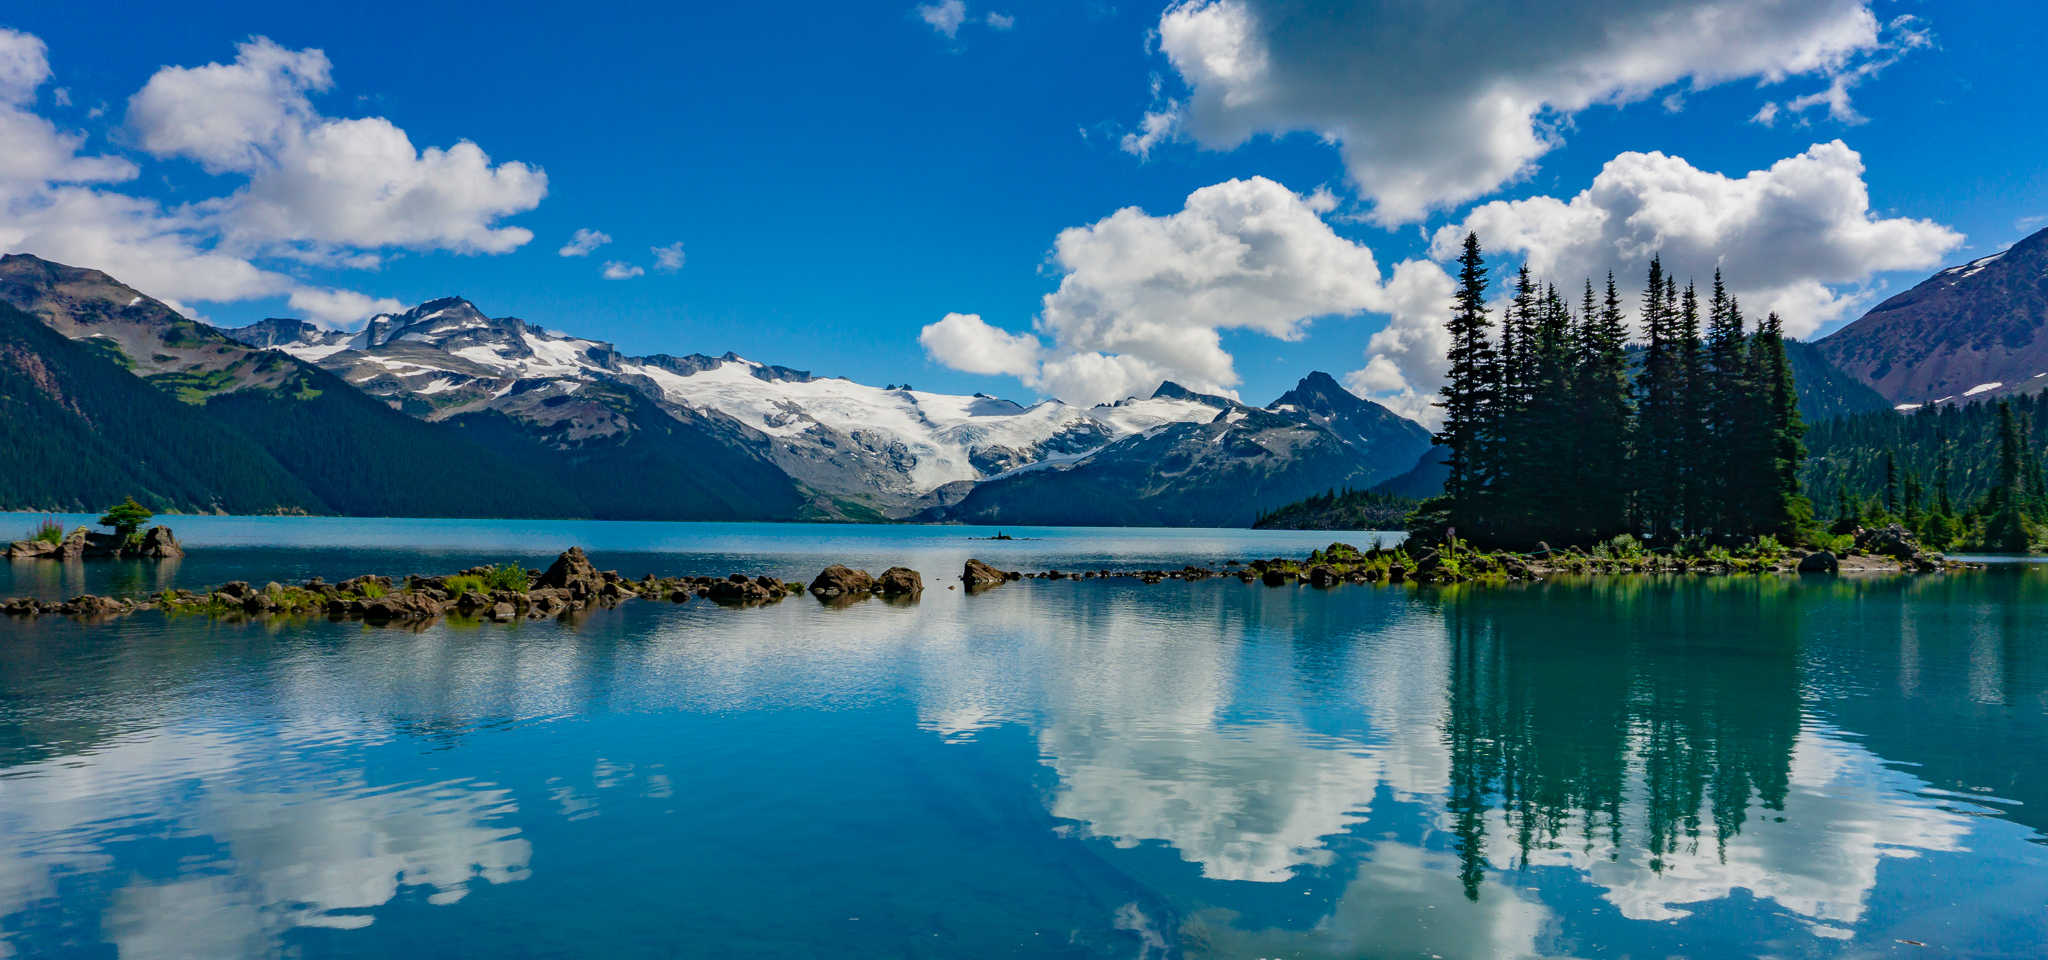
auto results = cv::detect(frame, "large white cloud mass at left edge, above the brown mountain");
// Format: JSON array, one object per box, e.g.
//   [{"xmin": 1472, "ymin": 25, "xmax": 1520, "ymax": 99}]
[{"xmin": 0, "ymin": 29, "xmax": 547, "ymax": 323}]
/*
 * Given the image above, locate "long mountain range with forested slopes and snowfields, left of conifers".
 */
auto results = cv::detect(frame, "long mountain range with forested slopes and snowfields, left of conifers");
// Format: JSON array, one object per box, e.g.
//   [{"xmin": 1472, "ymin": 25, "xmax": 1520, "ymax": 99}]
[{"xmin": 0, "ymin": 256, "xmax": 1430, "ymax": 526}]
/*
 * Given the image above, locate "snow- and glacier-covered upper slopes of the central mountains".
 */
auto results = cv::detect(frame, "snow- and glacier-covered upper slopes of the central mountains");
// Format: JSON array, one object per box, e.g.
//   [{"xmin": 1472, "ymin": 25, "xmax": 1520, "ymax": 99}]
[{"xmin": 229, "ymin": 297, "xmax": 1219, "ymax": 518}]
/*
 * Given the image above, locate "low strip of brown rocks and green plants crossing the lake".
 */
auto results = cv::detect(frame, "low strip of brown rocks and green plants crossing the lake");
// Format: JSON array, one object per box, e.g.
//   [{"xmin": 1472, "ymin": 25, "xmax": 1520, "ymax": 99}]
[{"xmin": 0, "ymin": 530, "xmax": 1982, "ymax": 622}]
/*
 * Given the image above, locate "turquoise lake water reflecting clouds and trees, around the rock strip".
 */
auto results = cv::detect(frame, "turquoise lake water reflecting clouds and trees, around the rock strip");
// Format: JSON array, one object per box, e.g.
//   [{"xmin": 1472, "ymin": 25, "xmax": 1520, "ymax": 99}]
[{"xmin": 0, "ymin": 518, "xmax": 2048, "ymax": 960}]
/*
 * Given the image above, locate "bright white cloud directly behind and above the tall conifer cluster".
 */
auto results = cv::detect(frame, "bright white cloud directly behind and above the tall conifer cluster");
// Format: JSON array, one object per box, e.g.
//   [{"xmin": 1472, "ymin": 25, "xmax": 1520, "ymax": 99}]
[{"xmin": 1348, "ymin": 141, "xmax": 1962, "ymax": 424}]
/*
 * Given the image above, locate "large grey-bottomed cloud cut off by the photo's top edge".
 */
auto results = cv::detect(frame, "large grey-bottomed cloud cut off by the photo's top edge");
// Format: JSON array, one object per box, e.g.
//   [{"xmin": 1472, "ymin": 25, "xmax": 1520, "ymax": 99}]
[{"xmin": 1133, "ymin": 0, "xmax": 1900, "ymax": 223}]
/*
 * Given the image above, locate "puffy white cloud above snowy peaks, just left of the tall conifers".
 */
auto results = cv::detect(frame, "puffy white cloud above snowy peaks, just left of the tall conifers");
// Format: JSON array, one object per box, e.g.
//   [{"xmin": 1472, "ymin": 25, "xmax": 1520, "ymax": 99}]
[{"xmin": 920, "ymin": 176, "xmax": 1442, "ymax": 403}]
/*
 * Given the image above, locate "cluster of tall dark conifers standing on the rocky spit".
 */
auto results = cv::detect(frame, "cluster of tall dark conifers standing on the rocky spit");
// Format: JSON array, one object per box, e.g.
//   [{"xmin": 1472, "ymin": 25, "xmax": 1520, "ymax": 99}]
[{"xmin": 1411, "ymin": 233, "xmax": 1812, "ymax": 549}]
